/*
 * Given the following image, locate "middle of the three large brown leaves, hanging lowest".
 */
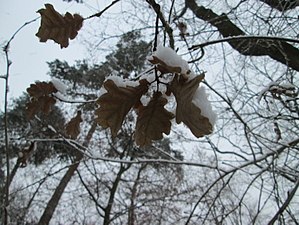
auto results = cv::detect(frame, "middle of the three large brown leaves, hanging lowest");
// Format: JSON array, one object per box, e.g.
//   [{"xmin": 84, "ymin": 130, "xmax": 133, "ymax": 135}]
[{"xmin": 135, "ymin": 92, "xmax": 174, "ymax": 146}]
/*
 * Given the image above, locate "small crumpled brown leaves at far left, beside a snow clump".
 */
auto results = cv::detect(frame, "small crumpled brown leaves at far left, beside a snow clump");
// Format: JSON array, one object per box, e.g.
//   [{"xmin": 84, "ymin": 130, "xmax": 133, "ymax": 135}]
[{"xmin": 26, "ymin": 82, "xmax": 57, "ymax": 119}]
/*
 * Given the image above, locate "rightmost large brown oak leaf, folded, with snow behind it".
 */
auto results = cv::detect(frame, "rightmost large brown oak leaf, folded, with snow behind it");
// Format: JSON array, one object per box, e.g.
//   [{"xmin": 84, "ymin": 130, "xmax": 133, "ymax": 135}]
[{"xmin": 169, "ymin": 74, "xmax": 213, "ymax": 137}]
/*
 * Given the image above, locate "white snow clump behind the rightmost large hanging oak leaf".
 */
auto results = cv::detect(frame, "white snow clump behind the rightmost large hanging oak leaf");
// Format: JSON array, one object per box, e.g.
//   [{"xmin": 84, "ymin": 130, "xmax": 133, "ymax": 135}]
[{"xmin": 192, "ymin": 86, "xmax": 217, "ymax": 126}]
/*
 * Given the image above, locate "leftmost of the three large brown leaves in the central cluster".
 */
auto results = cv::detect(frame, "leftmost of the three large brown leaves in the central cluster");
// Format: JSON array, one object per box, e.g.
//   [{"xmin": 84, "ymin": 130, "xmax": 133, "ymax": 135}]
[{"xmin": 96, "ymin": 80, "xmax": 148, "ymax": 137}]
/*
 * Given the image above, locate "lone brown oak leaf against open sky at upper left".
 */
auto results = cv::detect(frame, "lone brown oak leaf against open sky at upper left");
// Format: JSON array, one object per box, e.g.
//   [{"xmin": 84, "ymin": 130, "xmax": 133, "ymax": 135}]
[{"xmin": 36, "ymin": 4, "xmax": 83, "ymax": 48}]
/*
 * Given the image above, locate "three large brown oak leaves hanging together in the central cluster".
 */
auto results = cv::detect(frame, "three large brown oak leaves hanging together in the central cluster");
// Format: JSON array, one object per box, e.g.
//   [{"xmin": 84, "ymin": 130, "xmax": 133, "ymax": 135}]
[{"xmin": 96, "ymin": 75, "xmax": 213, "ymax": 146}]
